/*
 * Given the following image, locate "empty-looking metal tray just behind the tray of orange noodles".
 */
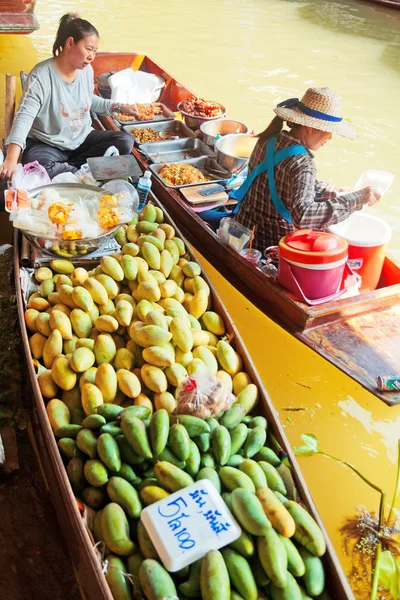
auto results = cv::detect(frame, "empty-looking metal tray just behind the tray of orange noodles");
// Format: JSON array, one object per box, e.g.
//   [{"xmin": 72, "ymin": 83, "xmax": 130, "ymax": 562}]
[{"xmin": 139, "ymin": 138, "xmax": 214, "ymax": 163}]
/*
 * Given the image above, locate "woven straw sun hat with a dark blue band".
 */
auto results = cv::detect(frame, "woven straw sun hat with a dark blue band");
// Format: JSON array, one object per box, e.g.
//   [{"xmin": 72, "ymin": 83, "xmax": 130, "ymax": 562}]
[{"xmin": 274, "ymin": 88, "xmax": 357, "ymax": 140}]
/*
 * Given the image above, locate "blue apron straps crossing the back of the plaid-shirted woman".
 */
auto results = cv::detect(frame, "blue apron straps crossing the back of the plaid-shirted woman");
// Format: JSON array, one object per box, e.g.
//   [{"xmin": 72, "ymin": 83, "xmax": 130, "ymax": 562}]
[{"xmin": 232, "ymin": 136, "xmax": 308, "ymax": 223}]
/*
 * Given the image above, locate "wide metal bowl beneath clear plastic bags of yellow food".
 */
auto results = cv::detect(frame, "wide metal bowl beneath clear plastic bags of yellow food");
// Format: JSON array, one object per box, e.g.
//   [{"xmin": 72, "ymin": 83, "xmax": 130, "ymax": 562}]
[{"xmin": 20, "ymin": 183, "xmax": 120, "ymax": 258}]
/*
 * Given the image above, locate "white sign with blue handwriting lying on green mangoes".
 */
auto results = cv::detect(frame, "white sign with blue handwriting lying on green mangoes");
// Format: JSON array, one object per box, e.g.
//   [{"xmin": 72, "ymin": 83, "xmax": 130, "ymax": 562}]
[{"xmin": 141, "ymin": 479, "xmax": 241, "ymax": 572}]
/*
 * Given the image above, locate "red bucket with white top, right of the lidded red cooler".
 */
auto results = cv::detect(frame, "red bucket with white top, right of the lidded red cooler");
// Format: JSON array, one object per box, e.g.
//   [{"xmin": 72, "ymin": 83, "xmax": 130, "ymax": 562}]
[{"xmin": 328, "ymin": 211, "xmax": 392, "ymax": 292}]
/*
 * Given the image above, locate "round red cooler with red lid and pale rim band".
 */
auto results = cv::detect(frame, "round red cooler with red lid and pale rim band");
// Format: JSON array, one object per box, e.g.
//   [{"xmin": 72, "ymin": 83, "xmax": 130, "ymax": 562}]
[{"xmin": 278, "ymin": 229, "xmax": 348, "ymax": 304}]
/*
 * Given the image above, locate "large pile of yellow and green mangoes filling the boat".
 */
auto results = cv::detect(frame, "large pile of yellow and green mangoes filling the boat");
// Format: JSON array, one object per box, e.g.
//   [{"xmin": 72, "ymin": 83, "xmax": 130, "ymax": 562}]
[{"xmin": 25, "ymin": 204, "xmax": 327, "ymax": 600}]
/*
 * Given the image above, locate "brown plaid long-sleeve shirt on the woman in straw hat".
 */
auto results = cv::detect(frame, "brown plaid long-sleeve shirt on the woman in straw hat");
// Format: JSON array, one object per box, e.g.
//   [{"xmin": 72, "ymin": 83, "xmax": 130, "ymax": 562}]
[{"xmin": 236, "ymin": 131, "xmax": 368, "ymax": 252}]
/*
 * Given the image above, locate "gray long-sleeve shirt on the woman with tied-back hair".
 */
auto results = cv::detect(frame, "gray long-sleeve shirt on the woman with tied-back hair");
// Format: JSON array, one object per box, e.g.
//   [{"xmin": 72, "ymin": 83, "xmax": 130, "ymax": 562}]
[{"xmin": 6, "ymin": 58, "xmax": 111, "ymax": 150}]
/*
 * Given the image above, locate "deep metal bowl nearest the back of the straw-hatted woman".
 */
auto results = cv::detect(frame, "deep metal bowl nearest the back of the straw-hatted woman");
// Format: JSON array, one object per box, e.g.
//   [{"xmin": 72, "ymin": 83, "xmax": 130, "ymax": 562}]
[{"xmin": 215, "ymin": 133, "xmax": 258, "ymax": 174}]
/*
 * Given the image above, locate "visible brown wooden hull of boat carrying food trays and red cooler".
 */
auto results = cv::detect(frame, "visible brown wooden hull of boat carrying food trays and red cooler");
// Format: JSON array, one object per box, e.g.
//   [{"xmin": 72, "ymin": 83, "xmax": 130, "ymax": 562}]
[{"xmin": 93, "ymin": 52, "xmax": 400, "ymax": 405}]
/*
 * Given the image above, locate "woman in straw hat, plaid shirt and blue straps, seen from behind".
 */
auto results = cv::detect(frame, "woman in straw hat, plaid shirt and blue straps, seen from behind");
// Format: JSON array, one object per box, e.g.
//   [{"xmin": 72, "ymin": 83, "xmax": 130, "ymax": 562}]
[{"xmin": 234, "ymin": 88, "xmax": 379, "ymax": 251}]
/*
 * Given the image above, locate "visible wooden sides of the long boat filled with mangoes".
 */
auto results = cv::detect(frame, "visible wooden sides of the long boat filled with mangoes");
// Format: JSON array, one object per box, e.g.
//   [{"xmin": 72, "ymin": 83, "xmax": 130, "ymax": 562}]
[{"xmin": 14, "ymin": 195, "xmax": 354, "ymax": 600}]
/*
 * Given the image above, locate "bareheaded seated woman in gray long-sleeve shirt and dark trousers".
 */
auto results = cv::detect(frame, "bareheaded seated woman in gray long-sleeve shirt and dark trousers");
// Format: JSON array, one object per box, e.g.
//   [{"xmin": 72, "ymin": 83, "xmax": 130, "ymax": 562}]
[{"xmin": 0, "ymin": 13, "xmax": 136, "ymax": 179}]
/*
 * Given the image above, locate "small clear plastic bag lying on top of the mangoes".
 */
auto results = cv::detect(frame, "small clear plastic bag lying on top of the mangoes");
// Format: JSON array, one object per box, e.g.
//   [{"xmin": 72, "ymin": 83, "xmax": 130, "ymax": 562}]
[{"xmin": 174, "ymin": 369, "xmax": 235, "ymax": 419}]
